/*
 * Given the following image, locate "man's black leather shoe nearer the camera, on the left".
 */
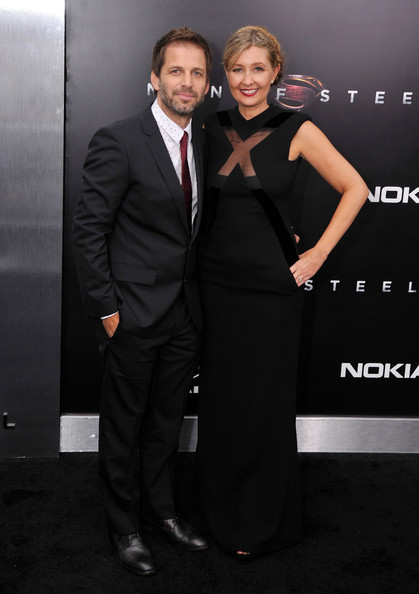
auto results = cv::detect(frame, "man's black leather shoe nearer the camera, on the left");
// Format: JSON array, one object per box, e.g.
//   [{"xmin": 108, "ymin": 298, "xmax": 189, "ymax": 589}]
[{"xmin": 108, "ymin": 531, "xmax": 157, "ymax": 575}]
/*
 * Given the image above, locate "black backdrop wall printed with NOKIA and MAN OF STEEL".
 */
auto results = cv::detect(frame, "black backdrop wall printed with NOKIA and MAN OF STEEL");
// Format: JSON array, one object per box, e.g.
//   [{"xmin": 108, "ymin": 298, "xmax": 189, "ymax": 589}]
[{"xmin": 62, "ymin": 0, "xmax": 419, "ymax": 416}]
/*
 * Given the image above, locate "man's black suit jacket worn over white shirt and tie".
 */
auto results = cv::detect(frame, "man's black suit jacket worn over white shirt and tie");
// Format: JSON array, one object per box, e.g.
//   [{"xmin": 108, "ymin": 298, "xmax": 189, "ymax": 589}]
[{"xmin": 73, "ymin": 108, "xmax": 205, "ymax": 331}]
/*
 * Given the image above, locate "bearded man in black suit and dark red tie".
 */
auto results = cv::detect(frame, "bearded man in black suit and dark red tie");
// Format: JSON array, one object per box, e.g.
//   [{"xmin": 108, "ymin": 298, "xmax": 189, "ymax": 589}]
[{"xmin": 73, "ymin": 27, "xmax": 211, "ymax": 575}]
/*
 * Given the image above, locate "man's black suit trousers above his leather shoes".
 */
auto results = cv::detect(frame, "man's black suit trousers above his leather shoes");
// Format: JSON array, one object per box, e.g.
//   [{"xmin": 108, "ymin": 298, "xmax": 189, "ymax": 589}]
[{"xmin": 99, "ymin": 299, "xmax": 200, "ymax": 534}]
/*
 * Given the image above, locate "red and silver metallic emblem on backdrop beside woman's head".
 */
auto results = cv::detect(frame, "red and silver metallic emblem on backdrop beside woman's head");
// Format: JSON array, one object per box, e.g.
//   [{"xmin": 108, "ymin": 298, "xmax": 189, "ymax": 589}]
[{"xmin": 278, "ymin": 74, "xmax": 325, "ymax": 111}]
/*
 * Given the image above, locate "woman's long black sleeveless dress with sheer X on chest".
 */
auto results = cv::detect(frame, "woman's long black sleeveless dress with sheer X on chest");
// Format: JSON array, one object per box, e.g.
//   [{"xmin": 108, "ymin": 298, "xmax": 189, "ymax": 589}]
[{"xmin": 197, "ymin": 106, "xmax": 309, "ymax": 553}]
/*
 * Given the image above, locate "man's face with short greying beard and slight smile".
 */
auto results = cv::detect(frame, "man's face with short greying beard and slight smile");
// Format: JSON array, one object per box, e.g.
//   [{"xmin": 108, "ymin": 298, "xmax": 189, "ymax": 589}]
[{"xmin": 151, "ymin": 43, "xmax": 209, "ymax": 125}]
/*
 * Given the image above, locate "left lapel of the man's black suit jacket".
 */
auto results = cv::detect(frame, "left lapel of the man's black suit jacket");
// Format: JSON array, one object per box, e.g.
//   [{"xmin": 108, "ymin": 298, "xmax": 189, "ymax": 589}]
[{"xmin": 141, "ymin": 108, "xmax": 189, "ymax": 234}]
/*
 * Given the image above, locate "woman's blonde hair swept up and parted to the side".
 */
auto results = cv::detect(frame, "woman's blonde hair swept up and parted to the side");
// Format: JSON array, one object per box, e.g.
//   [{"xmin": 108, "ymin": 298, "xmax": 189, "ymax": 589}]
[{"xmin": 222, "ymin": 25, "xmax": 285, "ymax": 85}]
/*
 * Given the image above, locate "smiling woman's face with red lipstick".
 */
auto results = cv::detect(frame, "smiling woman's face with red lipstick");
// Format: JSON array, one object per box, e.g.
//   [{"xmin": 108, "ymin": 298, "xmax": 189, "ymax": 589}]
[{"xmin": 226, "ymin": 46, "xmax": 280, "ymax": 117}]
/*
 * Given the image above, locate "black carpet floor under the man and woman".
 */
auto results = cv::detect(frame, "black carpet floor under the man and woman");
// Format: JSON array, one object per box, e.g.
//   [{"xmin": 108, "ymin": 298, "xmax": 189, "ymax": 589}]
[{"xmin": 0, "ymin": 454, "xmax": 419, "ymax": 594}]
